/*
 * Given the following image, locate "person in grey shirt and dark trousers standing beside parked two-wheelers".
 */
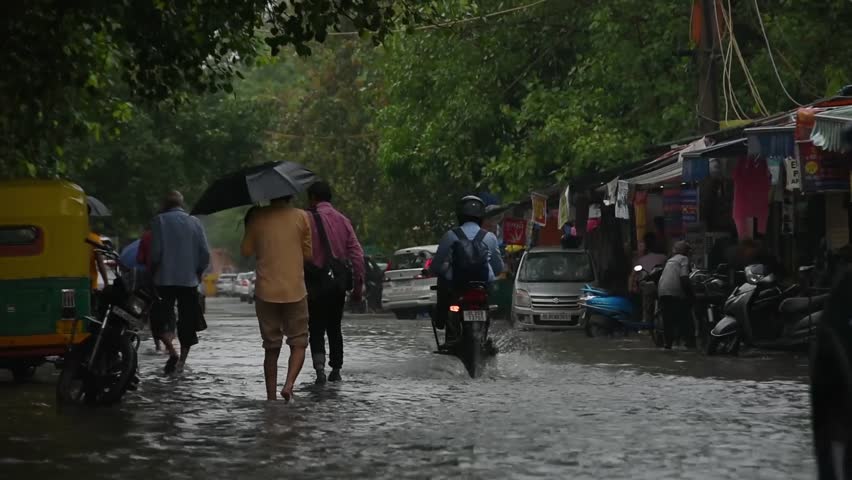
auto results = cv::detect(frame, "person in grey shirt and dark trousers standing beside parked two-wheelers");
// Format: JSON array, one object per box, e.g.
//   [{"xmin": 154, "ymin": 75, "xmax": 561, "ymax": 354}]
[{"xmin": 657, "ymin": 241, "xmax": 695, "ymax": 350}]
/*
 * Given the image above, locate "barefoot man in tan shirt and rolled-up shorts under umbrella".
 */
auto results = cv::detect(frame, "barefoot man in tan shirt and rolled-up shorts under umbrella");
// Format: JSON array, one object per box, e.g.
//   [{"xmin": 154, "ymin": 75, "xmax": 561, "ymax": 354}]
[{"xmin": 242, "ymin": 197, "xmax": 311, "ymax": 401}]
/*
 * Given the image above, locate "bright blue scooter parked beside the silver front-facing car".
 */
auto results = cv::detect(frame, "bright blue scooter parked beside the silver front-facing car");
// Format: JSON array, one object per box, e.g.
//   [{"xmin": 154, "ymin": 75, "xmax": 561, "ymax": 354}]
[{"xmin": 580, "ymin": 285, "xmax": 656, "ymax": 341}]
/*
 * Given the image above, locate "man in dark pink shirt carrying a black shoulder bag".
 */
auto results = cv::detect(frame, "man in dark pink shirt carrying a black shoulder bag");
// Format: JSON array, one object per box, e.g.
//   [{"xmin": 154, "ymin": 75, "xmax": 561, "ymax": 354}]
[{"xmin": 305, "ymin": 181, "xmax": 364, "ymax": 384}]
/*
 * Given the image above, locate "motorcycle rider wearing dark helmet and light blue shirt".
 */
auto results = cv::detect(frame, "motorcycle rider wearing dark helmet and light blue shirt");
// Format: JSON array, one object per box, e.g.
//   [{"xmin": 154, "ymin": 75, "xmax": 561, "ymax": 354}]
[{"xmin": 429, "ymin": 195, "xmax": 503, "ymax": 343}]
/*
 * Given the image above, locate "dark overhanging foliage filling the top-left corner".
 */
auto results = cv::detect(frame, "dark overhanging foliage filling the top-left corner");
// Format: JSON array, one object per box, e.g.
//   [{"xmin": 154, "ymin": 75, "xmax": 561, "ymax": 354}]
[{"xmin": 0, "ymin": 0, "xmax": 392, "ymax": 174}]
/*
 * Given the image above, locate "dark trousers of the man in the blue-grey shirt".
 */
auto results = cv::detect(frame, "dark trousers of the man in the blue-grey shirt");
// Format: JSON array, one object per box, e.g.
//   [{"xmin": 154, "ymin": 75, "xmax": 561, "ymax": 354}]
[{"xmin": 151, "ymin": 286, "xmax": 204, "ymax": 347}]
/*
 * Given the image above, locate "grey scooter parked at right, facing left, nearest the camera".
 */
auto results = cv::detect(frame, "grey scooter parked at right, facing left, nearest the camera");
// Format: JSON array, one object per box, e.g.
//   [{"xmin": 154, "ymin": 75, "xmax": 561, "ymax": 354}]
[{"xmin": 707, "ymin": 265, "xmax": 828, "ymax": 355}]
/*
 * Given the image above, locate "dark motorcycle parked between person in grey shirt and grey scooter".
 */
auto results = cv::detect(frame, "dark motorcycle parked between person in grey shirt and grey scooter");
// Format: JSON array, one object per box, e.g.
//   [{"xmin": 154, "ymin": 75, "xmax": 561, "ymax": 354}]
[{"xmin": 689, "ymin": 264, "xmax": 731, "ymax": 350}]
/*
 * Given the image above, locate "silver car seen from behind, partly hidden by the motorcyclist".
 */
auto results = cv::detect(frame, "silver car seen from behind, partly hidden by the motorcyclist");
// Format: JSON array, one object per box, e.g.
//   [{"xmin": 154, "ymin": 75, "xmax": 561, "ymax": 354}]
[{"xmin": 382, "ymin": 245, "xmax": 438, "ymax": 319}]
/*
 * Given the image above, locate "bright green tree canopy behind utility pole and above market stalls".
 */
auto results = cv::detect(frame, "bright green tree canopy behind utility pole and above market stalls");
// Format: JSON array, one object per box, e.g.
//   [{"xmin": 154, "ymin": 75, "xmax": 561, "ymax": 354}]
[{"xmin": 377, "ymin": 0, "xmax": 852, "ymax": 195}]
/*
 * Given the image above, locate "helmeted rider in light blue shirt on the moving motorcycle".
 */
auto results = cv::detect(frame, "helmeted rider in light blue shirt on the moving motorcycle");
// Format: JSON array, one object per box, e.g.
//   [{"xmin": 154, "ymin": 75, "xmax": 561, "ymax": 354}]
[{"xmin": 429, "ymin": 195, "xmax": 503, "ymax": 341}]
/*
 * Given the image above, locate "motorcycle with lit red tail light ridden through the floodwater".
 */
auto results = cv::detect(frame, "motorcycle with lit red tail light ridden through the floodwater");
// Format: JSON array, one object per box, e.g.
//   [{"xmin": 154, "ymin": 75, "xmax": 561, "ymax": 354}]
[{"xmin": 432, "ymin": 282, "xmax": 497, "ymax": 378}]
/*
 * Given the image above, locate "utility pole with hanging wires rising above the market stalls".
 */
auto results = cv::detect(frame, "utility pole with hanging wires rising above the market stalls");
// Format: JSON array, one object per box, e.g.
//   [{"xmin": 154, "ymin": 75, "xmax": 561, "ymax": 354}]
[{"xmin": 696, "ymin": 0, "xmax": 719, "ymax": 133}]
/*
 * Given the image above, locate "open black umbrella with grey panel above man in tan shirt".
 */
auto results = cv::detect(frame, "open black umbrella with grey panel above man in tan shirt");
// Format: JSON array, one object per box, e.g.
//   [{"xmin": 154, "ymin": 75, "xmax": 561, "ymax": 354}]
[{"xmin": 192, "ymin": 162, "xmax": 316, "ymax": 215}]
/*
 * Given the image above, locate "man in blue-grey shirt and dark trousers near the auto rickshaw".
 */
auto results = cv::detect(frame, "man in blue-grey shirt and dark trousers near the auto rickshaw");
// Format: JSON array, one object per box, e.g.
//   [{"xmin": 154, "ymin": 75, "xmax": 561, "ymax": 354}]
[{"xmin": 150, "ymin": 191, "xmax": 210, "ymax": 374}]
